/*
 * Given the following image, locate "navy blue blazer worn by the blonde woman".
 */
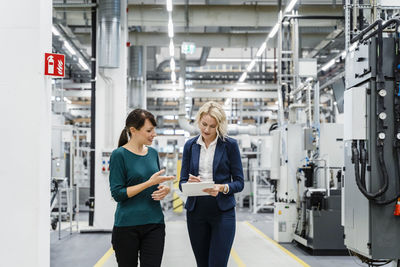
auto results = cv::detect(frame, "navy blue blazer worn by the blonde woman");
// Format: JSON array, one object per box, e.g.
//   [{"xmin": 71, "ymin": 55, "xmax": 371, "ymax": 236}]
[{"xmin": 179, "ymin": 136, "xmax": 244, "ymax": 211}]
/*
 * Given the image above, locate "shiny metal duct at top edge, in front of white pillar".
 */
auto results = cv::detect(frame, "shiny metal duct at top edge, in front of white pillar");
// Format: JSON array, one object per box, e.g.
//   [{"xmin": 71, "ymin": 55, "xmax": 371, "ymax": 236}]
[{"xmin": 98, "ymin": 0, "xmax": 121, "ymax": 68}]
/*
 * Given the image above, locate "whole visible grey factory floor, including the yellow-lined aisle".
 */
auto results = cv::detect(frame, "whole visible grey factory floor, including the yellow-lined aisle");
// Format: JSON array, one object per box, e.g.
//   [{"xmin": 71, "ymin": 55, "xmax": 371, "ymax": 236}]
[{"xmin": 51, "ymin": 209, "xmax": 372, "ymax": 267}]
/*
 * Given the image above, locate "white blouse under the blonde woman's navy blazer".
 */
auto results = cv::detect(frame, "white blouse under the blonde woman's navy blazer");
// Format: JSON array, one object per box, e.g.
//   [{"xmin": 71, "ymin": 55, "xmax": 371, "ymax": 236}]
[{"xmin": 197, "ymin": 135, "xmax": 218, "ymax": 182}]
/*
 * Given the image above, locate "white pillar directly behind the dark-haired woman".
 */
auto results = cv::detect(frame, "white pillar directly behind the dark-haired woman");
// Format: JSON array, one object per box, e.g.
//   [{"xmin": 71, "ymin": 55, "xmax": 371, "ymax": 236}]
[{"xmin": 94, "ymin": 1, "xmax": 128, "ymax": 230}]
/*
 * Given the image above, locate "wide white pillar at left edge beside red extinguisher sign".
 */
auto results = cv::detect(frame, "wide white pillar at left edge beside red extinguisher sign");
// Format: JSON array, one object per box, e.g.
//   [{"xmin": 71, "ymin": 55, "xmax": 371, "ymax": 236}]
[{"xmin": 0, "ymin": 0, "xmax": 52, "ymax": 267}]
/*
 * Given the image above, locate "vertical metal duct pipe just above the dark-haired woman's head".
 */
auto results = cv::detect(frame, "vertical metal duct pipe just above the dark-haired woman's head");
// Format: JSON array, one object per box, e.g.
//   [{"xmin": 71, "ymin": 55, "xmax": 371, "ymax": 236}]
[{"xmin": 128, "ymin": 46, "xmax": 146, "ymax": 109}]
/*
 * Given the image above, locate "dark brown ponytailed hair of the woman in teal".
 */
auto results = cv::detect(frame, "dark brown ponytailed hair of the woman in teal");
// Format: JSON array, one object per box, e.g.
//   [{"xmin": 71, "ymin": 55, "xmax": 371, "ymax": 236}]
[{"xmin": 118, "ymin": 108, "xmax": 157, "ymax": 147}]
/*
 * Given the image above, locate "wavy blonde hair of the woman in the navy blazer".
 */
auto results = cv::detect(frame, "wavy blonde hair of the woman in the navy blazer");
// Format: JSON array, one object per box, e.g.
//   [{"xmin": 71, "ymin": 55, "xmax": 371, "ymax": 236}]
[{"xmin": 196, "ymin": 101, "xmax": 228, "ymax": 139}]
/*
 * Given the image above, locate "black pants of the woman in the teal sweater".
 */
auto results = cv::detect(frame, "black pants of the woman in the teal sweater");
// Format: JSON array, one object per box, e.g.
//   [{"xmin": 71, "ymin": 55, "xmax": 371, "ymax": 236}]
[{"xmin": 111, "ymin": 224, "xmax": 165, "ymax": 267}]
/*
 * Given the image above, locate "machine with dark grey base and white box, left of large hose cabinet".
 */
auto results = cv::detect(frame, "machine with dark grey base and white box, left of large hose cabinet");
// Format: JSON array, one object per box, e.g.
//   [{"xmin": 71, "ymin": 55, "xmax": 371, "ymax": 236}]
[{"xmin": 293, "ymin": 124, "xmax": 348, "ymax": 255}]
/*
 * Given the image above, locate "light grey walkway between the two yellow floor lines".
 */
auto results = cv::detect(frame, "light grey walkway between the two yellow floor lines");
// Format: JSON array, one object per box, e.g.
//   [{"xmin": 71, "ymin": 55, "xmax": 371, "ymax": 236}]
[{"xmin": 95, "ymin": 221, "xmax": 309, "ymax": 267}]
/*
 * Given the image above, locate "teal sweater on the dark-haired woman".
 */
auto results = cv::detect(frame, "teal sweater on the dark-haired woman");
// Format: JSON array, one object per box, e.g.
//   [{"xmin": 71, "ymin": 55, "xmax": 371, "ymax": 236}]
[{"xmin": 109, "ymin": 147, "xmax": 164, "ymax": 226}]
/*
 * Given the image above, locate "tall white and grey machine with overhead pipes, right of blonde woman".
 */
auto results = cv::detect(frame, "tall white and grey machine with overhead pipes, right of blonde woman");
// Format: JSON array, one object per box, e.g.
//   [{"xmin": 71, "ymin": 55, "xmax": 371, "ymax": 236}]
[{"xmin": 271, "ymin": 9, "xmax": 347, "ymax": 255}]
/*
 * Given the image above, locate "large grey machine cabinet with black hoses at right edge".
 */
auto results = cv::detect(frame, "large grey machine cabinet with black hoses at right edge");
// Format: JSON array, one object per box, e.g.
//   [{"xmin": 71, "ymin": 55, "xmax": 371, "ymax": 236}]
[{"xmin": 343, "ymin": 19, "xmax": 400, "ymax": 266}]
